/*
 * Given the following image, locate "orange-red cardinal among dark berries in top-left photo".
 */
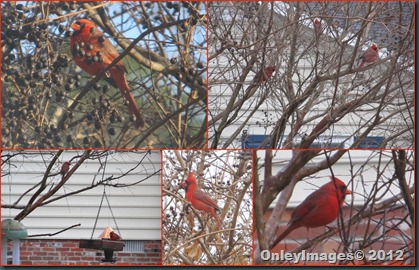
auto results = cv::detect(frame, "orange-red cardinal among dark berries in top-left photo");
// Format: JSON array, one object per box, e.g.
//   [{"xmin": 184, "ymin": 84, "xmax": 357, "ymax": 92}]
[{"xmin": 70, "ymin": 19, "xmax": 144, "ymax": 128}]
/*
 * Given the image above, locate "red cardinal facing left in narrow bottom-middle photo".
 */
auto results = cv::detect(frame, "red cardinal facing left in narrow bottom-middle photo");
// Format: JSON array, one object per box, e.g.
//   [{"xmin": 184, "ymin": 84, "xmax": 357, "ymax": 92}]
[{"xmin": 181, "ymin": 172, "xmax": 223, "ymax": 229}]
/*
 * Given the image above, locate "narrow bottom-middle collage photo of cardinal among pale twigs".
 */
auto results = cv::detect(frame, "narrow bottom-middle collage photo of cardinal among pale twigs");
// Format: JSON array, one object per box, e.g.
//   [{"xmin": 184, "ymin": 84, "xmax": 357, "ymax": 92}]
[{"xmin": 162, "ymin": 150, "xmax": 253, "ymax": 266}]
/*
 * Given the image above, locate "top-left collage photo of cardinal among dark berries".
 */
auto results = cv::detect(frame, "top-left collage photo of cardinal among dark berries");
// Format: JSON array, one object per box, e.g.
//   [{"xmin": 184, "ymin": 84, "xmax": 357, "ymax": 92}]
[{"xmin": 1, "ymin": 1, "xmax": 207, "ymax": 149}]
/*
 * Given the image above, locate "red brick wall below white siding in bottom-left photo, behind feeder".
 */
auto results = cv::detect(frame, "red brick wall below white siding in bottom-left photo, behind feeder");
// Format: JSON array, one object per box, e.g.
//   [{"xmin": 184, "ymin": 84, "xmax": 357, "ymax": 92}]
[{"xmin": 8, "ymin": 239, "xmax": 161, "ymax": 265}]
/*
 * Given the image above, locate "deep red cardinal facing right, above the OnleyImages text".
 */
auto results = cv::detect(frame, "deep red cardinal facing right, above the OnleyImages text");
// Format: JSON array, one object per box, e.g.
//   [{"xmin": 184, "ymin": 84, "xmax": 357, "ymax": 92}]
[{"xmin": 271, "ymin": 177, "xmax": 351, "ymax": 249}]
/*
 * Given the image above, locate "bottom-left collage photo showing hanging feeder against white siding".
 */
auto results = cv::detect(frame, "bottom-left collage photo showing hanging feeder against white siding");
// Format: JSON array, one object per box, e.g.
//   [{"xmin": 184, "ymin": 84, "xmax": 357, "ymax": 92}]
[{"xmin": 1, "ymin": 150, "xmax": 161, "ymax": 266}]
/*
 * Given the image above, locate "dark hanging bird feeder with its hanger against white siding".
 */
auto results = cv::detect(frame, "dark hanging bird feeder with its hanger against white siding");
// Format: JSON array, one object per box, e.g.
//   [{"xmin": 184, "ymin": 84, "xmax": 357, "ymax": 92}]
[{"xmin": 79, "ymin": 190, "xmax": 125, "ymax": 263}]
